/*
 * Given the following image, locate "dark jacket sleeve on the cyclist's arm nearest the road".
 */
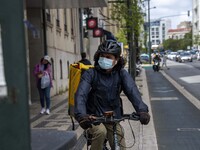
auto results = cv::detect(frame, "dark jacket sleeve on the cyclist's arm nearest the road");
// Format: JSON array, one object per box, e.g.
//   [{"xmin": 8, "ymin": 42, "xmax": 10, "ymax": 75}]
[{"xmin": 120, "ymin": 69, "xmax": 148, "ymax": 112}]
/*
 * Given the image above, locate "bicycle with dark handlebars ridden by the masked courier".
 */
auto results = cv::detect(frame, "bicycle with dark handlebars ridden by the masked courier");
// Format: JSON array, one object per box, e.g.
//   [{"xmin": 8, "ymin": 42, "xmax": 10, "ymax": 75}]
[{"xmin": 84, "ymin": 111, "xmax": 140, "ymax": 150}]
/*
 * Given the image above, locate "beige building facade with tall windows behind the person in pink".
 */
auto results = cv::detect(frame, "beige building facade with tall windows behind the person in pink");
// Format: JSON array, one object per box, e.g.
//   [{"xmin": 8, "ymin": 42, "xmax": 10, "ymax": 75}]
[{"xmin": 25, "ymin": 0, "xmax": 107, "ymax": 102}]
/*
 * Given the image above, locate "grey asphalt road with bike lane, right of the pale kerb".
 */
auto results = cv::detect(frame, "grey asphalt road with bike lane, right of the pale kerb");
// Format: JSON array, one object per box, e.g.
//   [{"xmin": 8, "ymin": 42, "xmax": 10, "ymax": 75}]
[{"xmin": 145, "ymin": 61, "xmax": 200, "ymax": 150}]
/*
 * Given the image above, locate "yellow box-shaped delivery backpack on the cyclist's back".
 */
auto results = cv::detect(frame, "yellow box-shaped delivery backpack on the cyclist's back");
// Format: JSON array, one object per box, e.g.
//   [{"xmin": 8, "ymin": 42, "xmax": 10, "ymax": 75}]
[{"xmin": 68, "ymin": 63, "xmax": 94, "ymax": 117}]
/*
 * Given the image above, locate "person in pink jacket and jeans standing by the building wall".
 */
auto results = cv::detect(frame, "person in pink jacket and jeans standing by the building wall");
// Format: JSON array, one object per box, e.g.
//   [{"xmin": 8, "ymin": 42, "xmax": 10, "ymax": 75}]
[{"xmin": 34, "ymin": 55, "xmax": 52, "ymax": 115}]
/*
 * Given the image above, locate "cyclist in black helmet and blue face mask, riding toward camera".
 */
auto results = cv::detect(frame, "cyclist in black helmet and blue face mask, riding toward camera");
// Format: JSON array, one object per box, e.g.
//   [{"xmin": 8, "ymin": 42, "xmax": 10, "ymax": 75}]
[{"xmin": 75, "ymin": 40, "xmax": 150, "ymax": 150}]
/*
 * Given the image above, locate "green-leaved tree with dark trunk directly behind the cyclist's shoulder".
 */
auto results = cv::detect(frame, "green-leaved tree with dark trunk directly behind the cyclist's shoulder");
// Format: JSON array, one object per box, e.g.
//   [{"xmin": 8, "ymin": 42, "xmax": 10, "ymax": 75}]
[{"xmin": 111, "ymin": 0, "xmax": 143, "ymax": 79}]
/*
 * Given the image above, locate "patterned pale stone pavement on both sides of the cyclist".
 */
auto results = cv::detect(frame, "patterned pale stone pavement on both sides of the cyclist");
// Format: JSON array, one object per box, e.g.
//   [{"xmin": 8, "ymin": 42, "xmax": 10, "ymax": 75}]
[{"xmin": 30, "ymin": 69, "xmax": 158, "ymax": 150}]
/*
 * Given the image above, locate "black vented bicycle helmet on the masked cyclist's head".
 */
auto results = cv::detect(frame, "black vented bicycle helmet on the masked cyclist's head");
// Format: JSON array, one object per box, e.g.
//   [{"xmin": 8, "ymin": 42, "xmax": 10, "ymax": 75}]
[{"xmin": 97, "ymin": 40, "xmax": 121, "ymax": 57}]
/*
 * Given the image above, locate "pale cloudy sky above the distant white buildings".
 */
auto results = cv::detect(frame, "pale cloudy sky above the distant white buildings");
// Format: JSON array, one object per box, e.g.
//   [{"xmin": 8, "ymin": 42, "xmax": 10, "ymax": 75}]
[{"xmin": 146, "ymin": 0, "xmax": 192, "ymax": 29}]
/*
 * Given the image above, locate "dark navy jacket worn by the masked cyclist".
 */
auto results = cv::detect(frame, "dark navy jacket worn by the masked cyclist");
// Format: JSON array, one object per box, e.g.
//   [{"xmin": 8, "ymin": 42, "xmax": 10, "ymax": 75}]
[{"xmin": 75, "ymin": 67, "xmax": 148, "ymax": 121}]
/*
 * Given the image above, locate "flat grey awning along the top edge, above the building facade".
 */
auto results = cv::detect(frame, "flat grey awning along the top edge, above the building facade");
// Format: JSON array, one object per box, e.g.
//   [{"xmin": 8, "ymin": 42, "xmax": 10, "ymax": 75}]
[{"xmin": 26, "ymin": 0, "xmax": 107, "ymax": 9}]
